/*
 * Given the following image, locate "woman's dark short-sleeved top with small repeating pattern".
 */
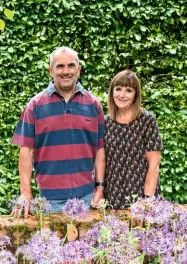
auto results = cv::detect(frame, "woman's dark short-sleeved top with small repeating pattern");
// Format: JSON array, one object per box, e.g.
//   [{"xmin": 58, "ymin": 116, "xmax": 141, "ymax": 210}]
[{"xmin": 104, "ymin": 110, "xmax": 163, "ymax": 209}]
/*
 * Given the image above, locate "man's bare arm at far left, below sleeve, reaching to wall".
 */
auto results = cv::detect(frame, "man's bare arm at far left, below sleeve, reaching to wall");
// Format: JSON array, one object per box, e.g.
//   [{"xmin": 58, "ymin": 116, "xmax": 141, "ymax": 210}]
[{"xmin": 12, "ymin": 147, "xmax": 34, "ymax": 218}]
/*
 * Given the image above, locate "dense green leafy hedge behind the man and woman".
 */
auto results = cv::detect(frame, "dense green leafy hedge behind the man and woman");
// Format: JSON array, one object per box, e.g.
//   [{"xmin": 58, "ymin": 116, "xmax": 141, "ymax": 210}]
[{"xmin": 0, "ymin": 0, "xmax": 187, "ymax": 212}]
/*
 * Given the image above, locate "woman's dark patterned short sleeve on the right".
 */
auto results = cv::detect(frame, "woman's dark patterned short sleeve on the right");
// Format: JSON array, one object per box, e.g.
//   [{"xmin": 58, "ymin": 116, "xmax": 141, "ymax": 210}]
[{"xmin": 144, "ymin": 115, "xmax": 163, "ymax": 151}]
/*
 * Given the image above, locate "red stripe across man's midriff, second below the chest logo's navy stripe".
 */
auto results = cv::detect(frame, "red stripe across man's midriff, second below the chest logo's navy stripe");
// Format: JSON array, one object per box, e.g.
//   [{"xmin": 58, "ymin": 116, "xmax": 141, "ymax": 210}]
[{"xmin": 34, "ymin": 144, "xmax": 97, "ymax": 162}]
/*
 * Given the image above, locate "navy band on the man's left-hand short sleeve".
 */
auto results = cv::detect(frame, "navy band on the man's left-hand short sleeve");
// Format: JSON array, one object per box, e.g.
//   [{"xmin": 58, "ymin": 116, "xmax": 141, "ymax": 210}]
[{"xmin": 15, "ymin": 120, "xmax": 35, "ymax": 138}]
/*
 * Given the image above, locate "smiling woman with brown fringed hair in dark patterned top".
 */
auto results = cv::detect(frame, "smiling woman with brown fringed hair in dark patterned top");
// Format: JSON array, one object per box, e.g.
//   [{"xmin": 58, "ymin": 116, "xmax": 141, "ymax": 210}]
[{"xmin": 105, "ymin": 70, "xmax": 162, "ymax": 209}]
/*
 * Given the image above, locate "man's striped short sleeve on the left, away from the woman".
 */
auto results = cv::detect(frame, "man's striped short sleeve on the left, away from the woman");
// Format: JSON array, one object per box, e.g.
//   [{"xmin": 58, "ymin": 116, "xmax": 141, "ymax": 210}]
[{"xmin": 12, "ymin": 106, "xmax": 35, "ymax": 148}]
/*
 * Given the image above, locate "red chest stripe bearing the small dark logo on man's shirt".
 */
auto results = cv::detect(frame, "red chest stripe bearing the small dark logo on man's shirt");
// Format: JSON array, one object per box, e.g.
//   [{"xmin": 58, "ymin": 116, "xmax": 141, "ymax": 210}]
[{"xmin": 35, "ymin": 114, "xmax": 98, "ymax": 134}]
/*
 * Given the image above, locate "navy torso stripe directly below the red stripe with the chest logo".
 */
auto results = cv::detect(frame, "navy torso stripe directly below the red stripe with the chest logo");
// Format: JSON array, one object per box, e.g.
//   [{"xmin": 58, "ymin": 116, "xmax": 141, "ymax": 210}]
[{"xmin": 35, "ymin": 129, "xmax": 98, "ymax": 148}]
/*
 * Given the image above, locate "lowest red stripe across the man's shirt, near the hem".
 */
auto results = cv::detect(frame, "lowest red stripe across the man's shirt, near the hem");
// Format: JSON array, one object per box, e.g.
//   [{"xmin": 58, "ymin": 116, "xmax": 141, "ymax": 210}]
[{"xmin": 36, "ymin": 171, "xmax": 94, "ymax": 189}]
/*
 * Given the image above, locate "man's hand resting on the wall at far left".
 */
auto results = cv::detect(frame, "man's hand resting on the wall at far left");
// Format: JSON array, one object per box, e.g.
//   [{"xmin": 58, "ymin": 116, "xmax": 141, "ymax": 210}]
[{"xmin": 11, "ymin": 195, "xmax": 32, "ymax": 218}]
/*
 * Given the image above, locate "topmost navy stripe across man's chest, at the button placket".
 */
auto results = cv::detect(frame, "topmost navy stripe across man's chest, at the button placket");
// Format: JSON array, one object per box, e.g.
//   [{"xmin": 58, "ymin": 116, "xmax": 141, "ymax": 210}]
[{"xmin": 33, "ymin": 101, "xmax": 98, "ymax": 119}]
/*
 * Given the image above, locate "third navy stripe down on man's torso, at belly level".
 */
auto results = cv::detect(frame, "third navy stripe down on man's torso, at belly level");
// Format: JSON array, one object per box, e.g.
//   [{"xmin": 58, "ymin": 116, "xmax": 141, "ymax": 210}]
[{"xmin": 34, "ymin": 158, "xmax": 93, "ymax": 177}]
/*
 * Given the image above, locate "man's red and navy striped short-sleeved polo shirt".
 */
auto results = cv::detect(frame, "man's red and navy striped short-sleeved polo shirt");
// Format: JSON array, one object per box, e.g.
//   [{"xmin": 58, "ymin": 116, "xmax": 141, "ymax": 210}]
[{"xmin": 12, "ymin": 82, "xmax": 104, "ymax": 200}]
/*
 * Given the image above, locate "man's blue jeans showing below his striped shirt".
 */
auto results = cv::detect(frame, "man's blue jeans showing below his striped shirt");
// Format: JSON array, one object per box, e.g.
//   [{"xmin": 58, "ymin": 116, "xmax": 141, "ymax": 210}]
[{"xmin": 48, "ymin": 193, "xmax": 93, "ymax": 213}]
